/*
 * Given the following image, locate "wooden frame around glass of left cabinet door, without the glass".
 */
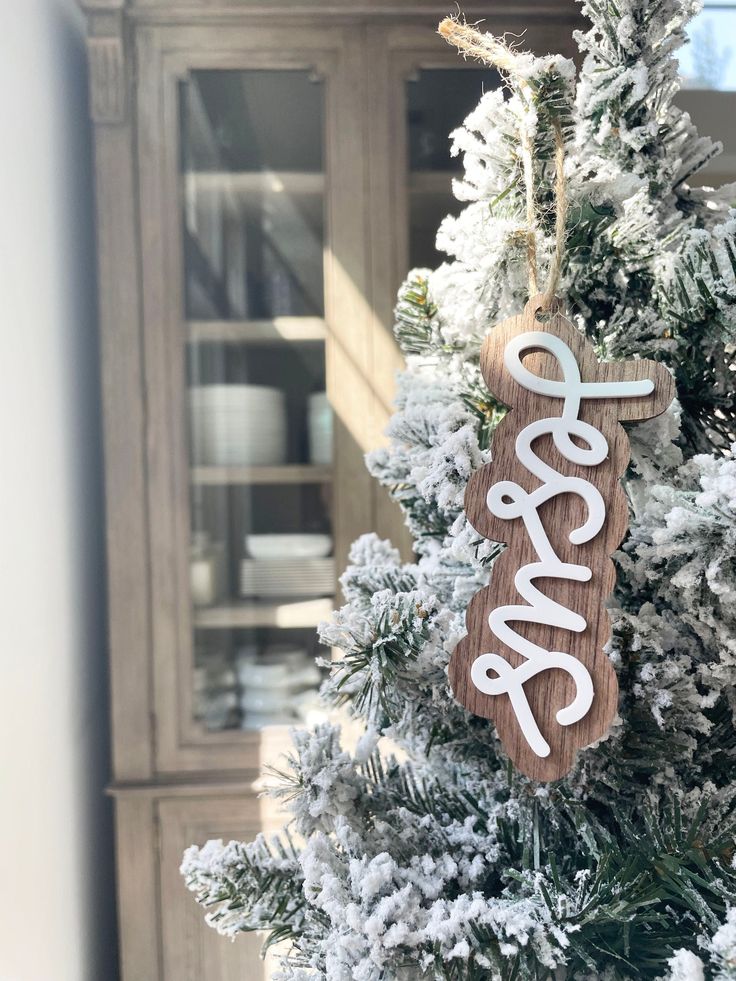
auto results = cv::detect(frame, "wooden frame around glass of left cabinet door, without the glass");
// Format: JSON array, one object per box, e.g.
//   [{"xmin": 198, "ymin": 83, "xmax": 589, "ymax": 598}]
[{"xmin": 137, "ymin": 23, "xmax": 374, "ymax": 777}]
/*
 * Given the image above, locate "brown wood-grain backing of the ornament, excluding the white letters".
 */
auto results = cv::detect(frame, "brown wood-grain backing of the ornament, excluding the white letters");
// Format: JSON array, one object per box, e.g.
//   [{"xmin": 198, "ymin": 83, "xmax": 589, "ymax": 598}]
[{"xmin": 449, "ymin": 296, "xmax": 675, "ymax": 781}]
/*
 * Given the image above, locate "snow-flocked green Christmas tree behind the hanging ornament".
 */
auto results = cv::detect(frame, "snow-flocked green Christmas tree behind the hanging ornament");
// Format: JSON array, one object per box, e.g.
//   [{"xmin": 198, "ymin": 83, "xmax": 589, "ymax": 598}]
[{"xmin": 183, "ymin": 0, "xmax": 736, "ymax": 981}]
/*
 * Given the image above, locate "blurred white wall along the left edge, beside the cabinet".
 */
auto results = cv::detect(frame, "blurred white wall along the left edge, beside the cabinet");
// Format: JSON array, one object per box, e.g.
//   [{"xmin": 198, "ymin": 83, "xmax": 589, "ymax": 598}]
[{"xmin": 0, "ymin": 0, "xmax": 115, "ymax": 981}]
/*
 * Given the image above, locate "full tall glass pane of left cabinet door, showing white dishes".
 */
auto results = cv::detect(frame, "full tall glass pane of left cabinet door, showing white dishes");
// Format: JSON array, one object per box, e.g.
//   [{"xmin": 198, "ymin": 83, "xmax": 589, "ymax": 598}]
[{"xmin": 180, "ymin": 70, "xmax": 335, "ymax": 734}]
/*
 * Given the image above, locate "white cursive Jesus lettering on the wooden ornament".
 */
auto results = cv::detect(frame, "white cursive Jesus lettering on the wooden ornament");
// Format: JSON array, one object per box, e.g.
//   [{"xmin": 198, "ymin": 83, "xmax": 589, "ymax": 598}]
[{"xmin": 470, "ymin": 331, "xmax": 654, "ymax": 756}]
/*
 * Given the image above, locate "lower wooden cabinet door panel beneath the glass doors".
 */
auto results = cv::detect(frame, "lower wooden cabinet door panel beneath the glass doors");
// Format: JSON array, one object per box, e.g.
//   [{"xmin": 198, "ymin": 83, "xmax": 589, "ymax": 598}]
[{"xmin": 115, "ymin": 783, "xmax": 284, "ymax": 981}]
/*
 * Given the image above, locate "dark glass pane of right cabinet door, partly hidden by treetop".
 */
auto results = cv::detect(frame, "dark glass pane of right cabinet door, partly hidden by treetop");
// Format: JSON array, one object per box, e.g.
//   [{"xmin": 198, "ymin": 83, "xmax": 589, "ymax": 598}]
[{"xmin": 406, "ymin": 68, "xmax": 500, "ymax": 268}]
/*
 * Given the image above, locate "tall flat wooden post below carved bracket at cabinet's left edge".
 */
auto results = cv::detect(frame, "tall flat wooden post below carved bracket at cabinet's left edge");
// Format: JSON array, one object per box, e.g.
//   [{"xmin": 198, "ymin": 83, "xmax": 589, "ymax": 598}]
[{"xmin": 88, "ymin": 71, "xmax": 153, "ymax": 780}]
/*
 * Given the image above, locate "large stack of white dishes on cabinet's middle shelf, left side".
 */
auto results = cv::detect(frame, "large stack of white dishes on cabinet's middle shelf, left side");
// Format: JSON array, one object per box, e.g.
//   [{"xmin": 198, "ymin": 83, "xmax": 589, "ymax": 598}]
[{"xmin": 189, "ymin": 385, "xmax": 286, "ymax": 467}]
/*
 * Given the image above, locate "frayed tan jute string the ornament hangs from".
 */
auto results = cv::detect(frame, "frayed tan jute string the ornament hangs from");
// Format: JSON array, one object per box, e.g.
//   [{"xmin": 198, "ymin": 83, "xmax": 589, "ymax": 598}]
[{"xmin": 438, "ymin": 17, "xmax": 567, "ymax": 309}]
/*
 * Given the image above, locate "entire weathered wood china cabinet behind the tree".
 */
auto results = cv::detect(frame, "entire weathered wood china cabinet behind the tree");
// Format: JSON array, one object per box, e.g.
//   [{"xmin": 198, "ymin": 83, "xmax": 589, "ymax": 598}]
[{"xmin": 82, "ymin": 0, "xmax": 577, "ymax": 981}]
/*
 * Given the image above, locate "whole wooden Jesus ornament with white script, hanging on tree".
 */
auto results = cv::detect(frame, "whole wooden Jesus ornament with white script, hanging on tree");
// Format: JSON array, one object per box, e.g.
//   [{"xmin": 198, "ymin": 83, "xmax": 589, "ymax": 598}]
[{"xmin": 449, "ymin": 295, "xmax": 675, "ymax": 780}]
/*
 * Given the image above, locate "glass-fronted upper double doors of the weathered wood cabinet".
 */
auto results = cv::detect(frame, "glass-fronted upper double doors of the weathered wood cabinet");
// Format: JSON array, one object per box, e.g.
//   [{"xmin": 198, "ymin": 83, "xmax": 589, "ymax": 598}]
[{"xmin": 138, "ymin": 26, "xmax": 524, "ymax": 774}]
